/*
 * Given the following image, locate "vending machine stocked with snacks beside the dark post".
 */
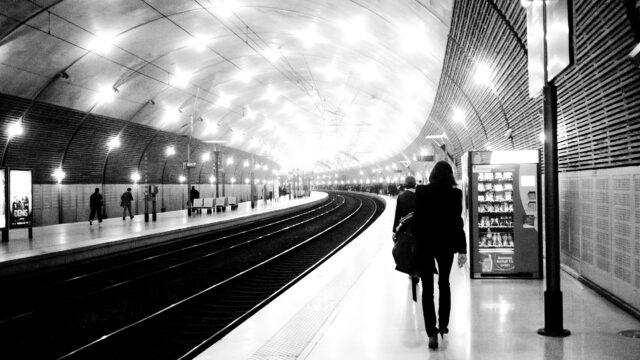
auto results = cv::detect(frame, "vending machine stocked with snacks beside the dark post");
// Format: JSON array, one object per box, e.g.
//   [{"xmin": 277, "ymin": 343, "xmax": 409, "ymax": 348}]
[{"xmin": 461, "ymin": 150, "xmax": 542, "ymax": 279}]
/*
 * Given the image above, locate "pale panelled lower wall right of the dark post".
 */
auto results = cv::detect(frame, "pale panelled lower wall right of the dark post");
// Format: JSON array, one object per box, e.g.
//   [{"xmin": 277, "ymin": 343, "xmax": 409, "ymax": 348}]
[{"xmin": 559, "ymin": 167, "xmax": 640, "ymax": 309}]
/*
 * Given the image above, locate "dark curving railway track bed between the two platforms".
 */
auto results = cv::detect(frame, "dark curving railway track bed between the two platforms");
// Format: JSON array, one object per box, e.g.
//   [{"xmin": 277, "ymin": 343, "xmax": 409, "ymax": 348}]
[{"xmin": 0, "ymin": 194, "xmax": 381, "ymax": 359}]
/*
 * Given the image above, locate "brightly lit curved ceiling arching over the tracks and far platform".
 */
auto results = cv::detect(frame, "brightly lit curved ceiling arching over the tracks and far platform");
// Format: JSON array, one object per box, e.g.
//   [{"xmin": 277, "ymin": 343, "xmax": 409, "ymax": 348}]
[{"xmin": 0, "ymin": 0, "xmax": 453, "ymax": 172}]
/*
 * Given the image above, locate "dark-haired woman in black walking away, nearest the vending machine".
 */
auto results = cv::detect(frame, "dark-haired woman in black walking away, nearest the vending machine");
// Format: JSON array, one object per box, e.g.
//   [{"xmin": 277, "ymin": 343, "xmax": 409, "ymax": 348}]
[{"xmin": 412, "ymin": 161, "xmax": 467, "ymax": 349}]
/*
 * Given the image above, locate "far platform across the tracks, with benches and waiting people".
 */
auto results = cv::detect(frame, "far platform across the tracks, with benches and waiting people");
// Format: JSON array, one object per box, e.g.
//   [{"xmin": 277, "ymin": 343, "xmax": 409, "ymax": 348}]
[{"xmin": 0, "ymin": 192, "xmax": 328, "ymax": 277}]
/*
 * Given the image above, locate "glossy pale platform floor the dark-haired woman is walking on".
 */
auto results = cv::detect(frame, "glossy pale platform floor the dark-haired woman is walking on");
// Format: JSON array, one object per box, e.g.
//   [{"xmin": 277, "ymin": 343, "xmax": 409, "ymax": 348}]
[{"xmin": 197, "ymin": 197, "xmax": 640, "ymax": 360}]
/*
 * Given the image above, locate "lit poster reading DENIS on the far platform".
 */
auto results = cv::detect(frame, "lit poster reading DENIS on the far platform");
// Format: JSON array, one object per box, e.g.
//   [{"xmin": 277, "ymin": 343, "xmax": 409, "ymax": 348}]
[{"xmin": 9, "ymin": 170, "xmax": 33, "ymax": 228}]
